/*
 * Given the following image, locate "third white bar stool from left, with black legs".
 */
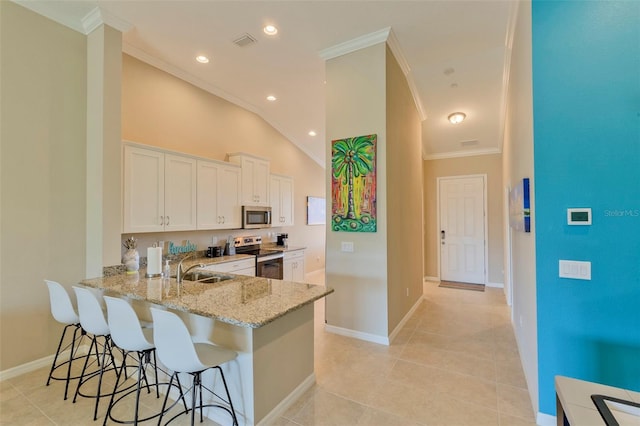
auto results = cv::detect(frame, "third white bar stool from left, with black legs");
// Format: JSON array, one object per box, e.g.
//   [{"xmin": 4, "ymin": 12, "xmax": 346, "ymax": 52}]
[{"xmin": 104, "ymin": 296, "xmax": 164, "ymax": 425}]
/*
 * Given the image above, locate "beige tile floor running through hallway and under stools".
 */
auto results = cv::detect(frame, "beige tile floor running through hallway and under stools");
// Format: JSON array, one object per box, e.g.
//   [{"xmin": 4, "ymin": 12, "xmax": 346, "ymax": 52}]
[{"xmin": 0, "ymin": 283, "xmax": 535, "ymax": 426}]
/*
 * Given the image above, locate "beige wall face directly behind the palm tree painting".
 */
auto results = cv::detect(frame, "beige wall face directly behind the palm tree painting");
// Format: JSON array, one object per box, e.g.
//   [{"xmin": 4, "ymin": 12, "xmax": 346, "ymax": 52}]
[{"xmin": 325, "ymin": 43, "xmax": 388, "ymax": 338}]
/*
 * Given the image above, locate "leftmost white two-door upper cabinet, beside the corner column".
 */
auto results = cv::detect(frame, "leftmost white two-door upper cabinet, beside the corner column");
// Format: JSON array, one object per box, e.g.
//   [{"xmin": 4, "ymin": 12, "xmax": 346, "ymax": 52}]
[{"xmin": 122, "ymin": 145, "xmax": 197, "ymax": 233}]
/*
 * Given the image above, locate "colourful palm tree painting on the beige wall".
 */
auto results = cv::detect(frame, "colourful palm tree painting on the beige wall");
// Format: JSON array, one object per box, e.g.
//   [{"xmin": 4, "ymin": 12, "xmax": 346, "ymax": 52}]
[{"xmin": 331, "ymin": 135, "xmax": 377, "ymax": 232}]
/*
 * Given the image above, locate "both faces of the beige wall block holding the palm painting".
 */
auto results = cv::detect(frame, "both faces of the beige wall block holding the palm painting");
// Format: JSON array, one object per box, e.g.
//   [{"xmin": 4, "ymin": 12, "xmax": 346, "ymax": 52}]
[{"xmin": 326, "ymin": 43, "xmax": 422, "ymax": 342}]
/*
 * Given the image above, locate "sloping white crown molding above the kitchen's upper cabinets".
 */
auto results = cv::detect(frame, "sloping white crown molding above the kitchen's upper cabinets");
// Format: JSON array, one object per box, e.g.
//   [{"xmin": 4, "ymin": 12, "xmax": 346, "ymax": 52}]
[{"xmin": 122, "ymin": 41, "xmax": 326, "ymax": 169}]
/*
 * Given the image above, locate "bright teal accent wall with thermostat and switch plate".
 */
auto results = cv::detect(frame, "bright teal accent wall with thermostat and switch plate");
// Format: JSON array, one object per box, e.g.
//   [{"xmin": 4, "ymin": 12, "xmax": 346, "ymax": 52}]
[{"xmin": 532, "ymin": 0, "xmax": 640, "ymax": 414}]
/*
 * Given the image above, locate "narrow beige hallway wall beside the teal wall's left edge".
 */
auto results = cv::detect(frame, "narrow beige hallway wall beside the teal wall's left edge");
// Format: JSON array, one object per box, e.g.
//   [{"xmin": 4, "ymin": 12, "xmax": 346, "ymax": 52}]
[{"xmin": 503, "ymin": 1, "xmax": 538, "ymax": 412}]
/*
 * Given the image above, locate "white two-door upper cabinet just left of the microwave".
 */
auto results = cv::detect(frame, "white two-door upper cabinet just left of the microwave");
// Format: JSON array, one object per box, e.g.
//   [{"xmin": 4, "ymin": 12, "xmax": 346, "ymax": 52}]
[{"xmin": 197, "ymin": 160, "xmax": 242, "ymax": 229}]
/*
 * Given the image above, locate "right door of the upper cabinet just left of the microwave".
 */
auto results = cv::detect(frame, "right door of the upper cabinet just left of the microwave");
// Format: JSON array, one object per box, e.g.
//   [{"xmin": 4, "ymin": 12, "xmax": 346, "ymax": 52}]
[{"xmin": 218, "ymin": 166, "xmax": 242, "ymax": 229}]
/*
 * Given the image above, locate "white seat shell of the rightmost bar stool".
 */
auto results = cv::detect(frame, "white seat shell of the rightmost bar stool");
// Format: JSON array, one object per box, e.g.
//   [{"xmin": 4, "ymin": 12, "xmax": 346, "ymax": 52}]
[{"xmin": 151, "ymin": 308, "xmax": 202, "ymax": 373}]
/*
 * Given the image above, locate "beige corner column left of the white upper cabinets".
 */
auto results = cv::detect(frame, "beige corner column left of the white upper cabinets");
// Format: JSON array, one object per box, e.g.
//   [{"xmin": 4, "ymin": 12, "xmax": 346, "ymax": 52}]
[{"xmin": 85, "ymin": 25, "xmax": 122, "ymax": 277}]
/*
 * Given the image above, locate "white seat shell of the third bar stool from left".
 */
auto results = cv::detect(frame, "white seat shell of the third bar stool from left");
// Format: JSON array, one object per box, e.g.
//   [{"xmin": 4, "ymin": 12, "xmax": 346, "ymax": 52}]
[{"xmin": 103, "ymin": 296, "xmax": 153, "ymax": 351}]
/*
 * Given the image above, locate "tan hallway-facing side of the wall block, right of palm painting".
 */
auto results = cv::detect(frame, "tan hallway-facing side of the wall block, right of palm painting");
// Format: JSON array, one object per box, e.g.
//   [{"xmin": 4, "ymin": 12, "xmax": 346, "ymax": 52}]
[{"xmin": 386, "ymin": 48, "xmax": 423, "ymax": 332}]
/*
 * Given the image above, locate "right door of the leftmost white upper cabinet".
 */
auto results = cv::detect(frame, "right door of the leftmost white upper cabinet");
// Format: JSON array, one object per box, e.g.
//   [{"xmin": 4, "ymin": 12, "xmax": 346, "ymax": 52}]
[{"xmin": 164, "ymin": 154, "xmax": 197, "ymax": 231}]
